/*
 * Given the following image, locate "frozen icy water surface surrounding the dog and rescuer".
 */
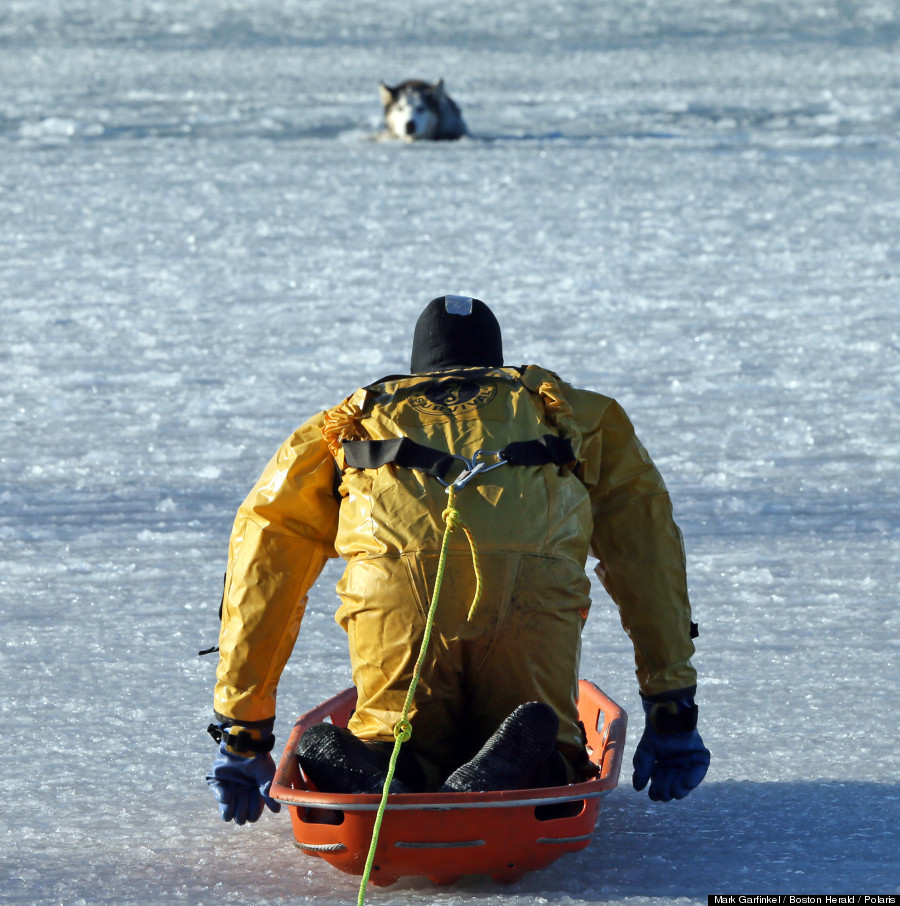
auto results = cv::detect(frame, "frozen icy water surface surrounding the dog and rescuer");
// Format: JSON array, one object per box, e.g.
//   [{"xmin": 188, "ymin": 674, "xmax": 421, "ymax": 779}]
[{"xmin": 0, "ymin": 0, "xmax": 900, "ymax": 906}]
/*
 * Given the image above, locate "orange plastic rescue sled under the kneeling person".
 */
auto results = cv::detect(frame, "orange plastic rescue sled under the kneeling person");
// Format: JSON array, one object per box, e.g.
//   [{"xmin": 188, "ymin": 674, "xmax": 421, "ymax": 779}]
[{"xmin": 271, "ymin": 680, "xmax": 627, "ymax": 886}]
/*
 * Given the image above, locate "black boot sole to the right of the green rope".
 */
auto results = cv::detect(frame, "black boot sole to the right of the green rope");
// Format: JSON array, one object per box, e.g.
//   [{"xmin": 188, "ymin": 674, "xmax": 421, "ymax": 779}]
[{"xmin": 439, "ymin": 702, "xmax": 565, "ymax": 793}]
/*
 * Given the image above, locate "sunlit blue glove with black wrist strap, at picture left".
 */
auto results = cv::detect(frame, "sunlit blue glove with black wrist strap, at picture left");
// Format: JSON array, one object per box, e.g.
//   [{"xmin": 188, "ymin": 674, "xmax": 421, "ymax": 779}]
[{"xmin": 206, "ymin": 724, "xmax": 281, "ymax": 824}]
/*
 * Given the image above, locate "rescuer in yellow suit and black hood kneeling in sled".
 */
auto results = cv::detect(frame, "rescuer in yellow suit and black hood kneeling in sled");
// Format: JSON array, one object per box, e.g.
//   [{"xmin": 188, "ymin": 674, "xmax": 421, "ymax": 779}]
[{"xmin": 207, "ymin": 296, "xmax": 709, "ymax": 823}]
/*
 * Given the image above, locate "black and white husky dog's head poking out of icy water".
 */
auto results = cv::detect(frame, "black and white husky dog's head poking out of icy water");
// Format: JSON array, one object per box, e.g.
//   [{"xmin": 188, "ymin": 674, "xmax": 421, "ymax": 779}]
[{"xmin": 378, "ymin": 79, "xmax": 469, "ymax": 142}]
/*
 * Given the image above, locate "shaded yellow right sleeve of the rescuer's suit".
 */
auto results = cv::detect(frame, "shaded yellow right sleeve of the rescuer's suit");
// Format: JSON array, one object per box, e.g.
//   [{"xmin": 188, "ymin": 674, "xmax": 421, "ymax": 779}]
[{"xmin": 571, "ymin": 391, "xmax": 697, "ymax": 695}]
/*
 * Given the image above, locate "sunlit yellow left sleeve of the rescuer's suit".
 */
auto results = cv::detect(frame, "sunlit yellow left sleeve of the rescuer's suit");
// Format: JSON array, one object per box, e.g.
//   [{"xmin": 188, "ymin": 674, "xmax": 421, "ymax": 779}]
[{"xmin": 214, "ymin": 413, "xmax": 339, "ymax": 726}]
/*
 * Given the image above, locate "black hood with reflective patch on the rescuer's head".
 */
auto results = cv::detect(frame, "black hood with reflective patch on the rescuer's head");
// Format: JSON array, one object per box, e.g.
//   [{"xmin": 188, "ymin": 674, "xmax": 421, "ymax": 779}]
[{"xmin": 410, "ymin": 296, "xmax": 503, "ymax": 374}]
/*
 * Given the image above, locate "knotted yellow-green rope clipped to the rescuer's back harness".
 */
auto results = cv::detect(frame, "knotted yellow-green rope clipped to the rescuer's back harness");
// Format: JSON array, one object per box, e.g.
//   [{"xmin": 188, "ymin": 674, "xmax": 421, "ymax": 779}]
[{"xmin": 356, "ymin": 485, "xmax": 481, "ymax": 906}]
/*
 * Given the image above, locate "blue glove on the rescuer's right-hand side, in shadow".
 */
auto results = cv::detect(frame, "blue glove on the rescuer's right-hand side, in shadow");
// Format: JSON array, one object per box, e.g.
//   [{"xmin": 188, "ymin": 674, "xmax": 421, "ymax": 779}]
[{"xmin": 631, "ymin": 694, "xmax": 709, "ymax": 802}]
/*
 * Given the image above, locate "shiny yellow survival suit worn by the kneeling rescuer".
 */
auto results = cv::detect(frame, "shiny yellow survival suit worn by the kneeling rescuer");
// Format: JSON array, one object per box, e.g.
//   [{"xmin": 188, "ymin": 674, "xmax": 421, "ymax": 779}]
[{"xmin": 215, "ymin": 365, "xmax": 696, "ymax": 777}]
